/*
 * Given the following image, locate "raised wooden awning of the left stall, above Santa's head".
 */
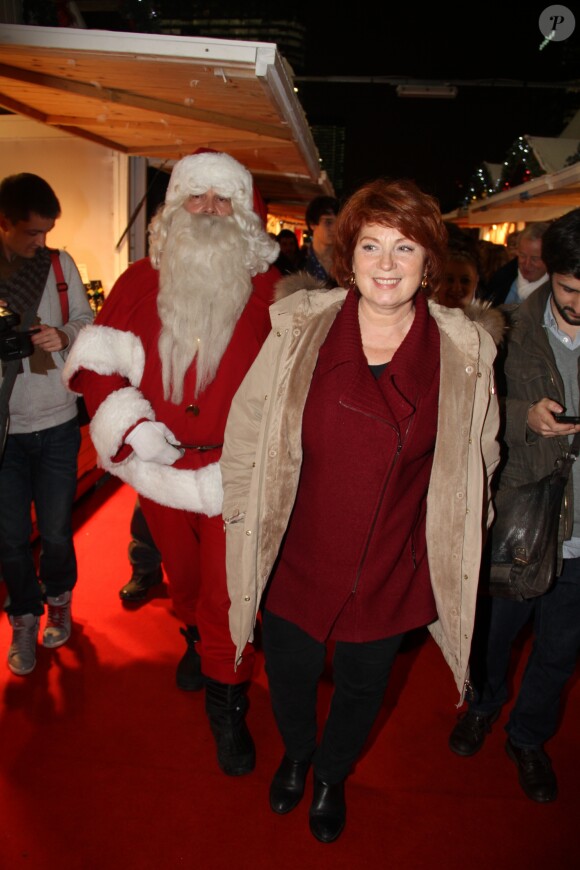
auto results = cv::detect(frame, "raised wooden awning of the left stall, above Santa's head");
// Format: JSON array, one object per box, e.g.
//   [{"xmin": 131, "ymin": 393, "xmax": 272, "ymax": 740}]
[{"xmin": 0, "ymin": 25, "xmax": 333, "ymax": 206}]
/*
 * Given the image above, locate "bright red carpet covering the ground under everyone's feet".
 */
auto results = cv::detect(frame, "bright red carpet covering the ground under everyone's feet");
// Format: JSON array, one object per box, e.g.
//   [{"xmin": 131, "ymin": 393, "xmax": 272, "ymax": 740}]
[{"xmin": 0, "ymin": 481, "xmax": 580, "ymax": 870}]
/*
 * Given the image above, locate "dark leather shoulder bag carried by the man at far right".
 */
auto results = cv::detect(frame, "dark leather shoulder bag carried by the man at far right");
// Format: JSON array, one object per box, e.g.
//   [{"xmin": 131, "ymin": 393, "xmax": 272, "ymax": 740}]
[{"xmin": 488, "ymin": 435, "xmax": 580, "ymax": 601}]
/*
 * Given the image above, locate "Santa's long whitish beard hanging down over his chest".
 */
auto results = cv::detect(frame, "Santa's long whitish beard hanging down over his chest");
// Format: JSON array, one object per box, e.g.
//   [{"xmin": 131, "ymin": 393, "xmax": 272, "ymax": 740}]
[{"xmin": 157, "ymin": 209, "xmax": 252, "ymax": 404}]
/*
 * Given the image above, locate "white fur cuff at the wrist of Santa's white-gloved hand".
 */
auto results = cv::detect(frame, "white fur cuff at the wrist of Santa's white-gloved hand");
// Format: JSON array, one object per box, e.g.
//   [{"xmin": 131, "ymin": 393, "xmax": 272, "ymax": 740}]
[{"xmin": 90, "ymin": 387, "xmax": 155, "ymax": 471}]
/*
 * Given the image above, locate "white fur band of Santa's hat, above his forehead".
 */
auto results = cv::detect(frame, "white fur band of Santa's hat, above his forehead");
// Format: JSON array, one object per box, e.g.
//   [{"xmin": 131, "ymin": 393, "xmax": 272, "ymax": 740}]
[{"xmin": 165, "ymin": 152, "xmax": 254, "ymax": 212}]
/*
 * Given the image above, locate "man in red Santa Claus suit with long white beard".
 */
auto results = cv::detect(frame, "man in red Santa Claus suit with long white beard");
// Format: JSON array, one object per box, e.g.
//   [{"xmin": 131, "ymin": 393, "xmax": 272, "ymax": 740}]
[{"xmin": 64, "ymin": 152, "xmax": 280, "ymax": 776}]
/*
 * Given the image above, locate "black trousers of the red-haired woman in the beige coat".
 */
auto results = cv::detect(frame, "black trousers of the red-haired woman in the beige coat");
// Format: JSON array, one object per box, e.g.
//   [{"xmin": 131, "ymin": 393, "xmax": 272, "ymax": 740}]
[{"xmin": 262, "ymin": 610, "xmax": 404, "ymax": 784}]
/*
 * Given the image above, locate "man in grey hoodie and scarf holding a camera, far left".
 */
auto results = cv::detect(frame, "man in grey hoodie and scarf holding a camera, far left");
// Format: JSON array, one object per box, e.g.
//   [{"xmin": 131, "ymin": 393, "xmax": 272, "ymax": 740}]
[{"xmin": 0, "ymin": 173, "xmax": 93, "ymax": 676}]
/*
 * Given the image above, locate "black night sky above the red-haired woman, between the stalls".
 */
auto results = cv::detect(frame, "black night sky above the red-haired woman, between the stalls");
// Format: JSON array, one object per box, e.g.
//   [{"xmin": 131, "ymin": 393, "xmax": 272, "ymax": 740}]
[{"xmin": 299, "ymin": 3, "xmax": 580, "ymax": 211}]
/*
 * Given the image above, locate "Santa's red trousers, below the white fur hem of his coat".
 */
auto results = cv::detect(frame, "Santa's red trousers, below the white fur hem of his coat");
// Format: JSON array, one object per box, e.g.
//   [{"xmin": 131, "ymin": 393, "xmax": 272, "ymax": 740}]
[{"xmin": 139, "ymin": 496, "xmax": 255, "ymax": 684}]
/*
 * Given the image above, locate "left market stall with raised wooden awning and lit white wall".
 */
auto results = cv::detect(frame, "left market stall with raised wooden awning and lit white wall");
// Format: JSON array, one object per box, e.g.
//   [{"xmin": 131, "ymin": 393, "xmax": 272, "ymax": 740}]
[{"xmin": 0, "ymin": 24, "xmax": 333, "ymax": 290}]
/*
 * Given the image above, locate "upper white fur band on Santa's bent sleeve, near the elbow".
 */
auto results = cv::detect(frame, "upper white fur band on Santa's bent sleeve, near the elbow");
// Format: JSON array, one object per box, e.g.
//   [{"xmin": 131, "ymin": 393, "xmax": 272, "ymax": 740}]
[{"xmin": 63, "ymin": 325, "xmax": 145, "ymax": 387}]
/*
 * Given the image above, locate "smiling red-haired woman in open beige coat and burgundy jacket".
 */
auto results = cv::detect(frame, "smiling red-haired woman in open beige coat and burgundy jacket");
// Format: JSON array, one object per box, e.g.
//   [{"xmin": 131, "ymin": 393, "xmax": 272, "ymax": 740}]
[{"xmin": 221, "ymin": 180, "xmax": 499, "ymax": 842}]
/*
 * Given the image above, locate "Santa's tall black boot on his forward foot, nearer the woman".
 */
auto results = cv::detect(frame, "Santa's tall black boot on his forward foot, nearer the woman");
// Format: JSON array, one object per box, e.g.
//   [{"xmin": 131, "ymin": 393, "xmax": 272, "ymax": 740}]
[{"xmin": 205, "ymin": 680, "xmax": 256, "ymax": 776}]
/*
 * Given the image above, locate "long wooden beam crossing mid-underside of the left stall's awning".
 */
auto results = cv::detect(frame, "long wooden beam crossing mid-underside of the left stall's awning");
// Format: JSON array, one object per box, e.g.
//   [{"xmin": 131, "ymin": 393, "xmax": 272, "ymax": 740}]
[{"xmin": 0, "ymin": 63, "xmax": 292, "ymax": 139}]
